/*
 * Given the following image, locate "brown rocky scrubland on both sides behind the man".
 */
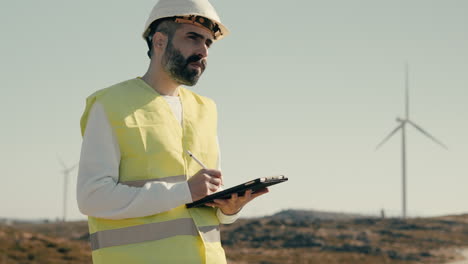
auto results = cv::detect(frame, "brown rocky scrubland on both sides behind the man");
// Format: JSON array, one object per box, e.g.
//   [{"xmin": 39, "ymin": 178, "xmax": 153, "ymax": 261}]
[{"xmin": 0, "ymin": 210, "xmax": 468, "ymax": 264}]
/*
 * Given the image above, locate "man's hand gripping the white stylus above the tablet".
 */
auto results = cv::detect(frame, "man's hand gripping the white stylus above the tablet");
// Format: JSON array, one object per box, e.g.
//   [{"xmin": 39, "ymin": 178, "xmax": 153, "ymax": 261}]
[{"xmin": 188, "ymin": 169, "xmax": 223, "ymax": 201}]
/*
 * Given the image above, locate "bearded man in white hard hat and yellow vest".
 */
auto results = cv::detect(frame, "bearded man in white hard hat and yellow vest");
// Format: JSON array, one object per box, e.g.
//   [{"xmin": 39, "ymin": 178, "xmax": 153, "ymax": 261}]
[{"xmin": 77, "ymin": 0, "xmax": 268, "ymax": 264}]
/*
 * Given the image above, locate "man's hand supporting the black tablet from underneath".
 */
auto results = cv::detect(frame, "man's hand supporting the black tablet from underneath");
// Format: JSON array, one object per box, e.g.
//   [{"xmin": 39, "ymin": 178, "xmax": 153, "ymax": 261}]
[{"xmin": 205, "ymin": 188, "xmax": 268, "ymax": 215}]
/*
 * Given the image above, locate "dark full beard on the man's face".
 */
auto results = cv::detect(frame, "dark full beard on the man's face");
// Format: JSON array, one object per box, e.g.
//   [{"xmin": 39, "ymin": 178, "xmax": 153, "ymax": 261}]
[{"xmin": 161, "ymin": 41, "xmax": 206, "ymax": 86}]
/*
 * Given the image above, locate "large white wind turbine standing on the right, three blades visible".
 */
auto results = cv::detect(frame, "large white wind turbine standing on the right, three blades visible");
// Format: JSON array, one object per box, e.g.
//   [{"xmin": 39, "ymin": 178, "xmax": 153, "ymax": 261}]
[{"xmin": 375, "ymin": 64, "xmax": 448, "ymax": 218}]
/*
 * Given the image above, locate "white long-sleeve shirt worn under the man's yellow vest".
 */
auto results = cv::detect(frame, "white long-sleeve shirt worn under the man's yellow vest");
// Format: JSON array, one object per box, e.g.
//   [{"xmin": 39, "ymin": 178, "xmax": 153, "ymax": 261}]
[{"xmin": 77, "ymin": 96, "xmax": 238, "ymax": 224}]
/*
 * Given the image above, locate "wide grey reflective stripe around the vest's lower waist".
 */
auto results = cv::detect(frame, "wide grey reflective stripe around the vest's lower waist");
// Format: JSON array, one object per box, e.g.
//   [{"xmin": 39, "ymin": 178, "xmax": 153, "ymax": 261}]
[{"xmin": 90, "ymin": 218, "xmax": 221, "ymax": 250}]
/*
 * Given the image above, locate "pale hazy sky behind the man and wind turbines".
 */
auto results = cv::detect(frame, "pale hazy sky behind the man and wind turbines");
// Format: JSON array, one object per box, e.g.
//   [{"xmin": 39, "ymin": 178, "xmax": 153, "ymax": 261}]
[{"xmin": 0, "ymin": 0, "xmax": 468, "ymax": 219}]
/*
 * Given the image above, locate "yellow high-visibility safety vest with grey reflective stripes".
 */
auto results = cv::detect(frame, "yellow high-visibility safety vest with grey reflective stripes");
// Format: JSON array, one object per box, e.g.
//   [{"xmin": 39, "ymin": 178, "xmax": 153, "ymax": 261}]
[{"xmin": 81, "ymin": 78, "xmax": 226, "ymax": 264}]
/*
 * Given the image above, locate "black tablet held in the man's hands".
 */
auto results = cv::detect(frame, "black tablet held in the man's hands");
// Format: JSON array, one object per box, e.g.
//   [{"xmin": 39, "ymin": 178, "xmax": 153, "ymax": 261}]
[{"xmin": 186, "ymin": 175, "xmax": 288, "ymax": 208}]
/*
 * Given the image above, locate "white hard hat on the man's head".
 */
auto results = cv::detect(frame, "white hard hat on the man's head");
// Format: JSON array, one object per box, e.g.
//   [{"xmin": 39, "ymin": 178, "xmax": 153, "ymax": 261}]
[{"xmin": 143, "ymin": 0, "xmax": 229, "ymax": 40}]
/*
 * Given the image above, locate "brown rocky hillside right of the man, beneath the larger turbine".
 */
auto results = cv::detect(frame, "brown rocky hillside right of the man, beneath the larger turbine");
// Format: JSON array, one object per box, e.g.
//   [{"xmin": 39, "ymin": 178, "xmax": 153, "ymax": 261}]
[{"xmin": 222, "ymin": 211, "xmax": 468, "ymax": 264}]
